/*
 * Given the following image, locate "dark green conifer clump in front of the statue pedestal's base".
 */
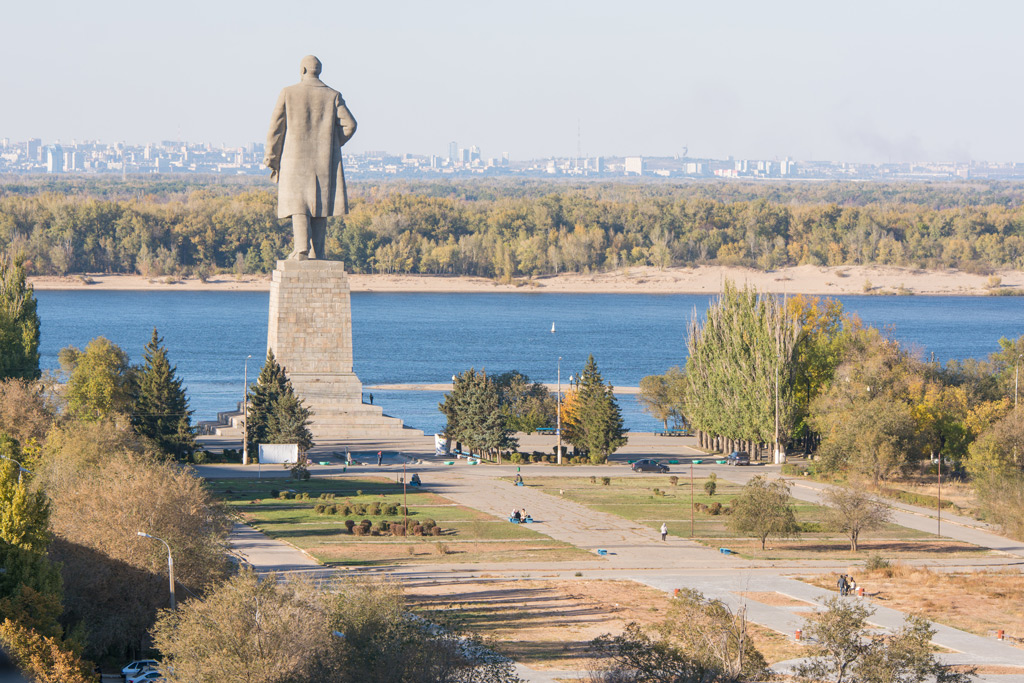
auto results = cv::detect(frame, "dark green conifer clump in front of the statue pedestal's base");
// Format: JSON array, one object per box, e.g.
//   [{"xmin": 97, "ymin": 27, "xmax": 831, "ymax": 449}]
[{"xmin": 247, "ymin": 351, "xmax": 313, "ymax": 454}]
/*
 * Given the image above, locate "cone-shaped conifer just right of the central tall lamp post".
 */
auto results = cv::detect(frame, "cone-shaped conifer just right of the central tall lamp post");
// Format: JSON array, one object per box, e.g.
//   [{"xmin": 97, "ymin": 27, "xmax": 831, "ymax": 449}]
[{"xmin": 562, "ymin": 354, "xmax": 629, "ymax": 464}]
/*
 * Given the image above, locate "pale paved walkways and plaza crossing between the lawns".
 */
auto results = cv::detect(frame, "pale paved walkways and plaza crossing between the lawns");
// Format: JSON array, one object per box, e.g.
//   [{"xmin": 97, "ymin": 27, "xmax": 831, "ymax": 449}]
[{"xmin": 199, "ymin": 434, "xmax": 1024, "ymax": 683}]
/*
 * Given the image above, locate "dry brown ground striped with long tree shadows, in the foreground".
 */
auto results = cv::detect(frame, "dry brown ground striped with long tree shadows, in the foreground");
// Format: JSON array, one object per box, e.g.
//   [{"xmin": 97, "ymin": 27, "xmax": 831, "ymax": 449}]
[{"xmin": 406, "ymin": 580, "xmax": 801, "ymax": 671}]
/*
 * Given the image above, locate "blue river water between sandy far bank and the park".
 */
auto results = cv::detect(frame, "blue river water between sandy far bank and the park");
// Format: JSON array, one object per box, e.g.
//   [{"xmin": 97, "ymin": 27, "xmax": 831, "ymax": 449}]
[{"xmin": 36, "ymin": 291, "xmax": 1024, "ymax": 433}]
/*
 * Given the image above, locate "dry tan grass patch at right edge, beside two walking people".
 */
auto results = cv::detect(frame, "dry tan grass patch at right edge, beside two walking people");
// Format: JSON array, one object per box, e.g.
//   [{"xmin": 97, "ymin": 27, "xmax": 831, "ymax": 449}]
[{"xmin": 803, "ymin": 563, "xmax": 1024, "ymax": 647}]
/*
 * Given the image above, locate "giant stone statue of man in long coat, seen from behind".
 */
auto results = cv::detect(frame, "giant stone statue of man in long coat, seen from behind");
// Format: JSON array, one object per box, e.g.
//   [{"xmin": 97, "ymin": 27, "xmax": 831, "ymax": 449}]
[{"xmin": 263, "ymin": 55, "xmax": 355, "ymax": 260}]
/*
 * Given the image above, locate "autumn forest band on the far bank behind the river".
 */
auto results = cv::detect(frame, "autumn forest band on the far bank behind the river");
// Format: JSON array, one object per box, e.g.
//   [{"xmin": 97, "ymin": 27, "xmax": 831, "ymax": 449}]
[{"xmin": 0, "ymin": 176, "xmax": 1024, "ymax": 281}]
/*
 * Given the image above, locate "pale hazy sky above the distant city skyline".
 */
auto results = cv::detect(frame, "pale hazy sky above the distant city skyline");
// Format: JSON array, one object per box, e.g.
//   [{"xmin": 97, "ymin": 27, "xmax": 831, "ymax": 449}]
[{"xmin": 0, "ymin": 0, "xmax": 1024, "ymax": 162}]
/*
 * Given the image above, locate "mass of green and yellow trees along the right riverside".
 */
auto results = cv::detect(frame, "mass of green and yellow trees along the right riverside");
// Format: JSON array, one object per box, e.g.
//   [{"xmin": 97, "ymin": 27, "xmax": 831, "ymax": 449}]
[{"xmin": 640, "ymin": 283, "xmax": 1024, "ymax": 538}]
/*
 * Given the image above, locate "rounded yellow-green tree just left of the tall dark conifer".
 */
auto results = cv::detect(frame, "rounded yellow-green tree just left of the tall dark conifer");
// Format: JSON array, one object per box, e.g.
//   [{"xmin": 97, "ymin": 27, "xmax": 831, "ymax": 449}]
[{"xmin": 59, "ymin": 337, "xmax": 134, "ymax": 420}]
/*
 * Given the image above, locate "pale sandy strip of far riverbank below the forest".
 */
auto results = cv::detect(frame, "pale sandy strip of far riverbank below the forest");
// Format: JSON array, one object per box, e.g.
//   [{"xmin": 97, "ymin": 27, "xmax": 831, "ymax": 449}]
[{"xmin": 29, "ymin": 265, "xmax": 1024, "ymax": 296}]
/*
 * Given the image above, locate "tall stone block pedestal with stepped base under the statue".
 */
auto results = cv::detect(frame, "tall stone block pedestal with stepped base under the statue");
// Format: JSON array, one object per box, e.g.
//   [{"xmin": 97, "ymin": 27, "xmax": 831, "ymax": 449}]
[{"xmin": 266, "ymin": 260, "xmax": 419, "ymax": 440}]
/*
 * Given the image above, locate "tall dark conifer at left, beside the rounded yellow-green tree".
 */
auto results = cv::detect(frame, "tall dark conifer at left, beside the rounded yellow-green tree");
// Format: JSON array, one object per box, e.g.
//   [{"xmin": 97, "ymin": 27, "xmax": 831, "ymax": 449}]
[{"xmin": 131, "ymin": 328, "xmax": 196, "ymax": 460}]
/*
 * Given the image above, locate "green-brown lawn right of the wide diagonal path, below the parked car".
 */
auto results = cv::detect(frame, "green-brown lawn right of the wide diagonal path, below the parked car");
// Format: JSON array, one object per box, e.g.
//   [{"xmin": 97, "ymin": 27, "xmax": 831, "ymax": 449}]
[{"xmin": 516, "ymin": 474, "xmax": 989, "ymax": 560}]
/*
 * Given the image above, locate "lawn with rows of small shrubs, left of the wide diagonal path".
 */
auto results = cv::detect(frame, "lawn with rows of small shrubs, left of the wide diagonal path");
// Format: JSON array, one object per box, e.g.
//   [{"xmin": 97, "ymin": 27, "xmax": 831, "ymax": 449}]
[{"xmin": 207, "ymin": 477, "xmax": 594, "ymax": 565}]
